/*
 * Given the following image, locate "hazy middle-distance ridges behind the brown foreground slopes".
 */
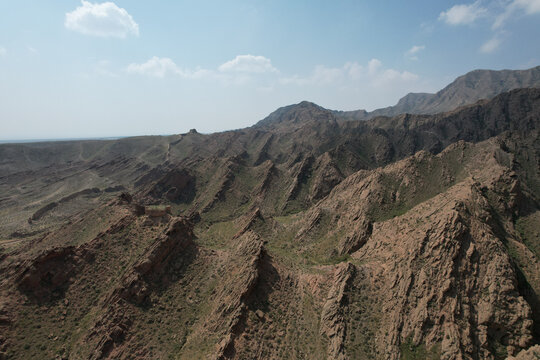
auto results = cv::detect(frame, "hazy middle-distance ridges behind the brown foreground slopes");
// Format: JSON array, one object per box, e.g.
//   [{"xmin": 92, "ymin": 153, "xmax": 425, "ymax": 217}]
[{"xmin": 0, "ymin": 89, "xmax": 540, "ymax": 250}]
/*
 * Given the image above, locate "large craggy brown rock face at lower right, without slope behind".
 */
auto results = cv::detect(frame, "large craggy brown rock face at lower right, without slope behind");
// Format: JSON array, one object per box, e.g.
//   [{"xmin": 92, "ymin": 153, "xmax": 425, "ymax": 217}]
[{"xmin": 357, "ymin": 179, "xmax": 532, "ymax": 359}]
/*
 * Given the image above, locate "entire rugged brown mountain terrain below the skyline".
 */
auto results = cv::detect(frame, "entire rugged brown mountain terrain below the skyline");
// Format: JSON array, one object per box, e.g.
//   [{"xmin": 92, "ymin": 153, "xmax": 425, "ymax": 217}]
[{"xmin": 0, "ymin": 68, "xmax": 540, "ymax": 360}]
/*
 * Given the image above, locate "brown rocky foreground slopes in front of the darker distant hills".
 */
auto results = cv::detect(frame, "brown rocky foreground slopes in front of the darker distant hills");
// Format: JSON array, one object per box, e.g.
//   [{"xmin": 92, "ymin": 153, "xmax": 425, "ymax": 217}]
[{"xmin": 5, "ymin": 134, "xmax": 540, "ymax": 359}]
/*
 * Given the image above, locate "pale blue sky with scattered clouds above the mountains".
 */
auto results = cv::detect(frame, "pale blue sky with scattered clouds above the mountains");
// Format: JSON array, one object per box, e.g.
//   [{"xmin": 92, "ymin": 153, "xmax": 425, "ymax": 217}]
[{"xmin": 0, "ymin": 0, "xmax": 540, "ymax": 140}]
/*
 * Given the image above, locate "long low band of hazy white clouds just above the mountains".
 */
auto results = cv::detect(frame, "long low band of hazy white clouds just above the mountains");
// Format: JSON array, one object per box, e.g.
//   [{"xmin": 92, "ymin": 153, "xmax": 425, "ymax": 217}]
[{"xmin": 125, "ymin": 55, "xmax": 425, "ymax": 109}]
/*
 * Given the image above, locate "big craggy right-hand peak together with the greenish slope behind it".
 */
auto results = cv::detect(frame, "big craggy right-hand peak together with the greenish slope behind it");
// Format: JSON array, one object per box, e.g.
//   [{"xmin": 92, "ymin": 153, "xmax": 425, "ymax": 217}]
[{"xmin": 297, "ymin": 136, "xmax": 533, "ymax": 359}]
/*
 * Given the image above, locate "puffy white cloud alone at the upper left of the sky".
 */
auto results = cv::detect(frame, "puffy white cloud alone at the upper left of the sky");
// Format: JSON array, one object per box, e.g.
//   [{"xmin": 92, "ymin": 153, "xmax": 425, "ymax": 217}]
[{"xmin": 64, "ymin": 0, "xmax": 139, "ymax": 38}]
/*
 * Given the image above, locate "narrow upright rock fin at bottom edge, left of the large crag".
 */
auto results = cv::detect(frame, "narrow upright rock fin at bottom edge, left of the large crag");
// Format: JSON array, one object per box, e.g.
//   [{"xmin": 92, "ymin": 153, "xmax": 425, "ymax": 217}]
[{"xmin": 321, "ymin": 263, "xmax": 355, "ymax": 360}]
